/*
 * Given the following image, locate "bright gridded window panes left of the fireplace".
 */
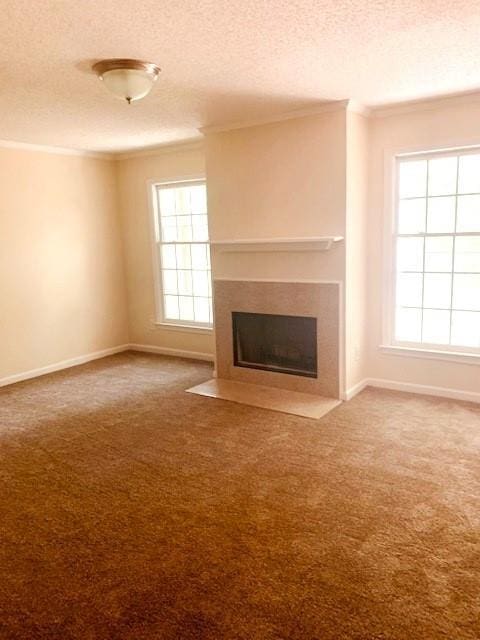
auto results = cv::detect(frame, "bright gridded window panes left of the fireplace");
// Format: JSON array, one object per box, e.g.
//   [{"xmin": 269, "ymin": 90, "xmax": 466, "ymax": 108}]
[{"xmin": 153, "ymin": 180, "xmax": 212, "ymax": 327}]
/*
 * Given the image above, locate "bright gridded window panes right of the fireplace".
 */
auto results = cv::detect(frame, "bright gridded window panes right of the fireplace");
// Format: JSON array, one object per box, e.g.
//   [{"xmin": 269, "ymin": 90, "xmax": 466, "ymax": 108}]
[{"xmin": 393, "ymin": 149, "xmax": 480, "ymax": 352}]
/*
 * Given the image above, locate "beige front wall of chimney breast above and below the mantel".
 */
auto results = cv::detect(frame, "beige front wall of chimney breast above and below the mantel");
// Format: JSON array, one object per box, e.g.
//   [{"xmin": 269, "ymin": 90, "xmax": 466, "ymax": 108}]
[{"xmin": 205, "ymin": 110, "xmax": 345, "ymax": 280}]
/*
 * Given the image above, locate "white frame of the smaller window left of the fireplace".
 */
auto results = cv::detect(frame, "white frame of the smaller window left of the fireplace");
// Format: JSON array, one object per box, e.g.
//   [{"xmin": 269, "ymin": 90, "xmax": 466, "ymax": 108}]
[{"xmin": 147, "ymin": 174, "xmax": 213, "ymax": 333}]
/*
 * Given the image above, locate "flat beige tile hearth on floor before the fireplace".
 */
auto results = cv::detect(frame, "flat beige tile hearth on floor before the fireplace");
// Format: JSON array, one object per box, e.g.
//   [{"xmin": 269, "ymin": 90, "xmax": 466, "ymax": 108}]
[{"xmin": 187, "ymin": 378, "xmax": 340, "ymax": 420}]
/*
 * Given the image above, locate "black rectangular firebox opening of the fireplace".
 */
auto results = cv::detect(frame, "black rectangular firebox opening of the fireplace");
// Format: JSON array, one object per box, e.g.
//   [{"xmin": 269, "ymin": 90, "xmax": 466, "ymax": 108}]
[{"xmin": 232, "ymin": 311, "xmax": 317, "ymax": 378}]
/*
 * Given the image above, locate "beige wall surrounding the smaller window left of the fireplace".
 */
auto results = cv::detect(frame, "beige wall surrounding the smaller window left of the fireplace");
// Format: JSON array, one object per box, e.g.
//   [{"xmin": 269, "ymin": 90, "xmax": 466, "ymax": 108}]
[{"xmin": 117, "ymin": 145, "xmax": 214, "ymax": 354}]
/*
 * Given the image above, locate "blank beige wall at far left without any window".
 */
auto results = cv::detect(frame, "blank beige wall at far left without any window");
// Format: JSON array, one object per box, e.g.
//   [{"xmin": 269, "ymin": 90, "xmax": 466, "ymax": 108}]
[{"xmin": 0, "ymin": 149, "xmax": 128, "ymax": 378}]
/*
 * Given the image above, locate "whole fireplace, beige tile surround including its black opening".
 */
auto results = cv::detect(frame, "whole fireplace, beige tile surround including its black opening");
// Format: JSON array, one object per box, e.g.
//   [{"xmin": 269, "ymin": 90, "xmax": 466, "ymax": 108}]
[{"xmin": 213, "ymin": 279, "xmax": 341, "ymax": 398}]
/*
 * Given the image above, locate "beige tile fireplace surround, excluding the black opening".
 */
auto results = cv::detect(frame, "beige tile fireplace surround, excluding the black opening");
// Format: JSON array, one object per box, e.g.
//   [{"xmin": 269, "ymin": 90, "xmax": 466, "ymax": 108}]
[{"xmin": 214, "ymin": 279, "xmax": 340, "ymax": 398}]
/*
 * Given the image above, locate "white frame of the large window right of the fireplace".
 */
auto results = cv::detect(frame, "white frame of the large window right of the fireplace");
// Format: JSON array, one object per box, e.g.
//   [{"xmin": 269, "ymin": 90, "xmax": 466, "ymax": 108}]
[{"xmin": 379, "ymin": 142, "xmax": 480, "ymax": 365}]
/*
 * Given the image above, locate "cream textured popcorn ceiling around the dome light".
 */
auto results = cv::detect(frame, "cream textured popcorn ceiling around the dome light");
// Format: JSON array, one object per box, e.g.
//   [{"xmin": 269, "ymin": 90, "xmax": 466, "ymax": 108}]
[{"xmin": 0, "ymin": 0, "xmax": 480, "ymax": 151}]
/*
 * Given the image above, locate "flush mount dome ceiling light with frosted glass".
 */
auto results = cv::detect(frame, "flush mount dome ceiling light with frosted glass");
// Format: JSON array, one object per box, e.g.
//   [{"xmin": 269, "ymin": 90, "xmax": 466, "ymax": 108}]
[{"xmin": 92, "ymin": 58, "xmax": 160, "ymax": 104}]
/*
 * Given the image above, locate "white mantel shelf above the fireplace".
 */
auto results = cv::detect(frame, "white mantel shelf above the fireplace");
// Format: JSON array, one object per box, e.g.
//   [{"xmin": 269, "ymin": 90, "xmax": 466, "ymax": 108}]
[{"xmin": 210, "ymin": 236, "xmax": 343, "ymax": 253}]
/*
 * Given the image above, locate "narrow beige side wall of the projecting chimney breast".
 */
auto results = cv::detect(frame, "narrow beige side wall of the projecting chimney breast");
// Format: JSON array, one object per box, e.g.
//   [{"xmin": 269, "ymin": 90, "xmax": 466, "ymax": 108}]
[{"xmin": 345, "ymin": 111, "xmax": 370, "ymax": 389}]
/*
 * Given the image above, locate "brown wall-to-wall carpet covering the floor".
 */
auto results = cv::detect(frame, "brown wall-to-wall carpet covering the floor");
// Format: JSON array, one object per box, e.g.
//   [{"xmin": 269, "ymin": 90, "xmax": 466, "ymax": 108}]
[{"xmin": 0, "ymin": 353, "xmax": 480, "ymax": 640}]
